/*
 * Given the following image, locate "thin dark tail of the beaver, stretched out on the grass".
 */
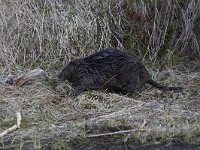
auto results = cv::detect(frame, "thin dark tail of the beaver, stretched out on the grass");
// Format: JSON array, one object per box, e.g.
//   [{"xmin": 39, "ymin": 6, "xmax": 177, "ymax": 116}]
[{"xmin": 147, "ymin": 79, "xmax": 183, "ymax": 92}]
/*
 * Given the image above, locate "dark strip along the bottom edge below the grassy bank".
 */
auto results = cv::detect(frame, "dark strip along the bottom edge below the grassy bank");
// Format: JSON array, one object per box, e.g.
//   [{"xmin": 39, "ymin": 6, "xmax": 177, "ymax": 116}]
[{"xmin": 71, "ymin": 137, "xmax": 200, "ymax": 150}]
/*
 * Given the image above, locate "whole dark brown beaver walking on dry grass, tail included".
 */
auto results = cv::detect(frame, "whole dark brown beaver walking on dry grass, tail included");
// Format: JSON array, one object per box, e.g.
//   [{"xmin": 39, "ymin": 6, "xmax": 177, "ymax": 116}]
[{"xmin": 58, "ymin": 48, "xmax": 182, "ymax": 96}]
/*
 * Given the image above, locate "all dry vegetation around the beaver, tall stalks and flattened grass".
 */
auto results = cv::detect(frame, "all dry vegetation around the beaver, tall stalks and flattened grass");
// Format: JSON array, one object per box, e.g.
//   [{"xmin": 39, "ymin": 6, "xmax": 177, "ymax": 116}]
[{"xmin": 0, "ymin": 0, "xmax": 200, "ymax": 149}]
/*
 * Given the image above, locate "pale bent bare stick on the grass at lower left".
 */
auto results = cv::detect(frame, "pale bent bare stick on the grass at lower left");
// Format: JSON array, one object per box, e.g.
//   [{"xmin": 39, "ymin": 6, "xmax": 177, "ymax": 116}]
[{"xmin": 0, "ymin": 112, "xmax": 22, "ymax": 138}]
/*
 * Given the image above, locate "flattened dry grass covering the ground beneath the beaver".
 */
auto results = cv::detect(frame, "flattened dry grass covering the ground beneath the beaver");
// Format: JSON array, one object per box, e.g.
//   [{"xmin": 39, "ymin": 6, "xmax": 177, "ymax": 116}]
[{"xmin": 0, "ymin": 69, "xmax": 200, "ymax": 147}]
